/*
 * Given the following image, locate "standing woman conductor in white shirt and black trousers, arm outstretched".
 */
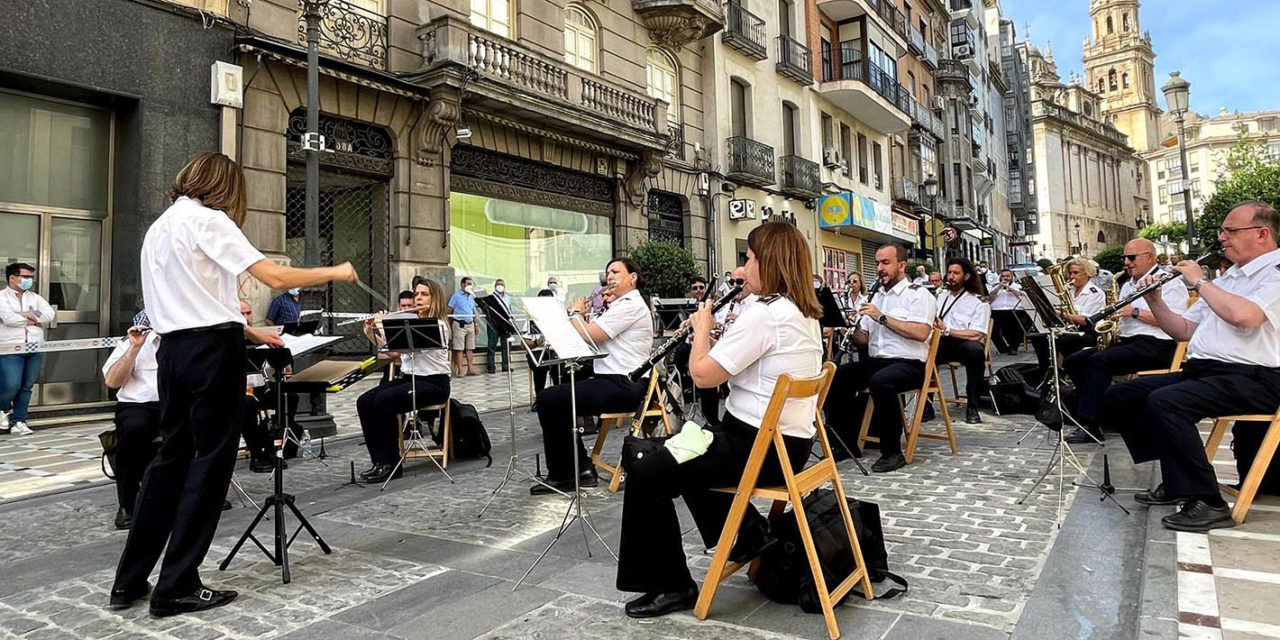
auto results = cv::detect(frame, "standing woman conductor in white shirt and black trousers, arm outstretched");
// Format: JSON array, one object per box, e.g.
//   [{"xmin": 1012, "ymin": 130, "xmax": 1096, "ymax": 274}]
[{"xmin": 110, "ymin": 152, "xmax": 357, "ymax": 617}]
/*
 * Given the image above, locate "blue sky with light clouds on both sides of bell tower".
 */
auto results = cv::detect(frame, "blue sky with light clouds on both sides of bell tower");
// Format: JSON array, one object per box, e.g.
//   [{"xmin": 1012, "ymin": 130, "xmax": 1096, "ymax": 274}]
[{"xmin": 1000, "ymin": 0, "xmax": 1280, "ymax": 115}]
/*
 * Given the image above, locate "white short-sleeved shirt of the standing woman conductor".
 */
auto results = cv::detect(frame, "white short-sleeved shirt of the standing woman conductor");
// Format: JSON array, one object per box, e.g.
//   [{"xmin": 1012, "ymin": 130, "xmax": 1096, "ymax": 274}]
[{"xmin": 142, "ymin": 196, "xmax": 264, "ymax": 335}]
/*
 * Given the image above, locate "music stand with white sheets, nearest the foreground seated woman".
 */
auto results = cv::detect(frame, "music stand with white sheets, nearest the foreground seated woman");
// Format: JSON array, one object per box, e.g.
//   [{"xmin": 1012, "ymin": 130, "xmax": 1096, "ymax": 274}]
[{"xmin": 511, "ymin": 298, "xmax": 618, "ymax": 591}]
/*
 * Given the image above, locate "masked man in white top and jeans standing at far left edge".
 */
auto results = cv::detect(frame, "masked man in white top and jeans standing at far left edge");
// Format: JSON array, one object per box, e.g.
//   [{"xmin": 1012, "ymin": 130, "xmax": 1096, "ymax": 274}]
[{"xmin": 0, "ymin": 262, "xmax": 54, "ymax": 435}]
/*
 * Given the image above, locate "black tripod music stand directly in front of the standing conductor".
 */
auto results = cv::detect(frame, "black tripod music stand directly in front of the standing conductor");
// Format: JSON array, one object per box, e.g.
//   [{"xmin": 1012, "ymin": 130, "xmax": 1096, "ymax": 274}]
[{"xmin": 218, "ymin": 348, "xmax": 333, "ymax": 584}]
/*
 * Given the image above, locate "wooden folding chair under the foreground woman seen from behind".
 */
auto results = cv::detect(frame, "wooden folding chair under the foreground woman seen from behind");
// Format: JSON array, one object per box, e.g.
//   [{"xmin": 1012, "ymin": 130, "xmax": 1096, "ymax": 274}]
[{"xmin": 694, "ymin": 362, "xmax": 874, "ymax": 640}]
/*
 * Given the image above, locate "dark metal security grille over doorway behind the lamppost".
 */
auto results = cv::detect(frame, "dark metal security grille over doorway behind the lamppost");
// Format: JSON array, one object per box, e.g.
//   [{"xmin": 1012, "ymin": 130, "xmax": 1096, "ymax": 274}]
[{"xmin": 284, "ymin": 163, "xmax": 390, "ymax": 356}]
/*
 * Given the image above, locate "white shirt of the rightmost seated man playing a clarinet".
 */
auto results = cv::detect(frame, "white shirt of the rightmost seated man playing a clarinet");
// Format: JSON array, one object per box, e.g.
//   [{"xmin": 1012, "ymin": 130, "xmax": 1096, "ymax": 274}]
[{"xmin": 1184, "ymin": 250, "xmax": 1280, "ymax": 367}]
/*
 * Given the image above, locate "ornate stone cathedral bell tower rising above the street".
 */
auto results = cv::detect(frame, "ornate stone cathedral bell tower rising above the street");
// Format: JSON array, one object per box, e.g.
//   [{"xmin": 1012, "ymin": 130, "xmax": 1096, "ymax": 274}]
[{"xmin": 1083, "ymin": 0, "xmax": 1160, "ymax": 154}]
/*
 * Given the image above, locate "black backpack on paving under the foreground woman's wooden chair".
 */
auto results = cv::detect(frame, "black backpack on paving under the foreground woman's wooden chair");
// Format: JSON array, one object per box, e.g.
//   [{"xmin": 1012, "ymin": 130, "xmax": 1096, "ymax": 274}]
[{"xmin": 755, "ymin": 489, "xmax": 908, "ymax": 613}]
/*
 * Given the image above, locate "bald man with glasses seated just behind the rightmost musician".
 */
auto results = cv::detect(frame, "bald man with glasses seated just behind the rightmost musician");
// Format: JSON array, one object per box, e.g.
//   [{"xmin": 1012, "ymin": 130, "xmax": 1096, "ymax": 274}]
[{"xmin": 1062, "ymin": 238, "xmax": 1188, "ymax": 444}]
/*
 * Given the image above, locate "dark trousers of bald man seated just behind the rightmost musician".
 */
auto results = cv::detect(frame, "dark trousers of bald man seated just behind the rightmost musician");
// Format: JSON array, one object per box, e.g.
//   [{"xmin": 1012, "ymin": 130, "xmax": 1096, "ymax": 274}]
[{"xmin": 1062, "ymin": 335, "xmax": 1178, "ymax": 422}]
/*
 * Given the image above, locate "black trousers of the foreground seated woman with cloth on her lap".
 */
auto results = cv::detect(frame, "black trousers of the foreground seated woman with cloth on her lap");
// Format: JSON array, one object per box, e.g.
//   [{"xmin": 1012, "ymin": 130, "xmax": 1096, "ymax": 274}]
[{"xmin": 617, "ymin": 413, "xmax": 813, "ymax": 593}]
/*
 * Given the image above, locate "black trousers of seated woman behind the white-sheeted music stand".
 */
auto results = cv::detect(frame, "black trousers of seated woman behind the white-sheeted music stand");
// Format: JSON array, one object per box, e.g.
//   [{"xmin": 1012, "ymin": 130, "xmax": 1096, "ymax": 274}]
[{"xmin": 538, "ymin": 375, "xmax": 649, "ymax": 481}]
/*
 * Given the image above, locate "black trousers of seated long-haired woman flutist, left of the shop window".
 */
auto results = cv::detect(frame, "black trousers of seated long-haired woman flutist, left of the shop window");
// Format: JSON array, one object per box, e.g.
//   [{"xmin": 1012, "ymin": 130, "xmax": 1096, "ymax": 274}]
[{"xmin": 356, "ymin": 374, "xmax": 449, "ymax": 465}]
